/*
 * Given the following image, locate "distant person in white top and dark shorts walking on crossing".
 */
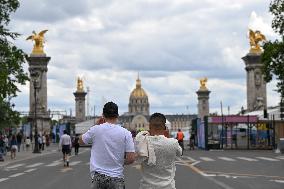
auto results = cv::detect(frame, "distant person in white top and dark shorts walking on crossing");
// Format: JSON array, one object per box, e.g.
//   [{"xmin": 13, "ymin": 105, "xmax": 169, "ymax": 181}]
[{"xmin": 59, "ymin": 130, "xmax": 72, "ymax": 167}]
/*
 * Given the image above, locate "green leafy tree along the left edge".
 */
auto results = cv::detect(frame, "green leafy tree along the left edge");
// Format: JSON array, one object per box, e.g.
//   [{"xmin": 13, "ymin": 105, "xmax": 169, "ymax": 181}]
[{"xmin": 0, "ymin": 0, "xmax": 29, "ymax": 128}]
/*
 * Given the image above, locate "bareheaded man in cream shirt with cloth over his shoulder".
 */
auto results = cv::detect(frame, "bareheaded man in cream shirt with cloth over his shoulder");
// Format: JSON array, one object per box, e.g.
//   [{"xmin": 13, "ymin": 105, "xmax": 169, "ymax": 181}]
[{"xmin": 135, "ymin": 113, "xmax": 182, "ymax": 189}]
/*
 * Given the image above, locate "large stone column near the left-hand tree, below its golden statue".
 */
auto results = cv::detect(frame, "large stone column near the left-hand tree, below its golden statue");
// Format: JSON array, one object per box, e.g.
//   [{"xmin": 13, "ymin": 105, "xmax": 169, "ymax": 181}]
[{"xmin": 26, "ymin": 54, "xmax": 51, "ymax": 133}]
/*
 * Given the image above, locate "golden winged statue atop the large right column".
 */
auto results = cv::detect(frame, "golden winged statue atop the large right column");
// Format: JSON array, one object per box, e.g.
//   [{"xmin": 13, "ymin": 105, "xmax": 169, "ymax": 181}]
[{"xmin": 249, "ymin": 29, "xmax": 266, "ymax": 53}]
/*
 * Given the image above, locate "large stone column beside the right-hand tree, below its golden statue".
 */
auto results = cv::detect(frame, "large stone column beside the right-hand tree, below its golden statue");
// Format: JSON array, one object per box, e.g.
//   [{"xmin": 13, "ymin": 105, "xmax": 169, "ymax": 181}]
[{"xmin": 242, "ymin": 52, "xmax": 267, "ymax": 112}]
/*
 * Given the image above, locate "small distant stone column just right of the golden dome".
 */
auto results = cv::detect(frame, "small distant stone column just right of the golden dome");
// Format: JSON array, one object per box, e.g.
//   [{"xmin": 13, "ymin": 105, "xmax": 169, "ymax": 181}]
[{"xmin": 196, "ymin": 88, "xmax": 211, "ymax": 119}]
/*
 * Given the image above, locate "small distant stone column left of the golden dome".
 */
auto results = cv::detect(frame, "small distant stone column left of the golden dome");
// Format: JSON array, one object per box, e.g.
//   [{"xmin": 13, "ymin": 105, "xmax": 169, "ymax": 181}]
[{"xmin": 73, "ymin": 91, "xmax": 87, "ymax": 123}]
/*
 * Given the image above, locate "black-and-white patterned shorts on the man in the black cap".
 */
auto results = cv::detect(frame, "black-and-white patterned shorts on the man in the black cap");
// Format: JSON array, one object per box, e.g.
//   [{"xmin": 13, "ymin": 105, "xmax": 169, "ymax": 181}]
[{"xmin": 92, "ymin": 172, "xmax": 125, "ymax": 189}]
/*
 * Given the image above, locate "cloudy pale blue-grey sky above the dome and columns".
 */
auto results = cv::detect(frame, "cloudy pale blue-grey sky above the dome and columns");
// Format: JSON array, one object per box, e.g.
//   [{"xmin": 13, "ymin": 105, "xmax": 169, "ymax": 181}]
[{"xmin": 9, "ymin": 0, "xmax": 279, "ymax": 118}]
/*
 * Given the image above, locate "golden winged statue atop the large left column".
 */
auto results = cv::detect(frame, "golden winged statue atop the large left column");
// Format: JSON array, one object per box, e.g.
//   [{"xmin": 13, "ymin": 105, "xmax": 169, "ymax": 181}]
[{"xmin": 26, "ymin": 30, "xmax": 48, "ymax": 54}]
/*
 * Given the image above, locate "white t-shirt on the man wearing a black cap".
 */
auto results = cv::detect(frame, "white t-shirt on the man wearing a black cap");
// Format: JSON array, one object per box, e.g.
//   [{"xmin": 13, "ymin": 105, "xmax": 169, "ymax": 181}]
[{"xmin": 82, "ymin": 123, "xmax": 135, "ymax": 178}]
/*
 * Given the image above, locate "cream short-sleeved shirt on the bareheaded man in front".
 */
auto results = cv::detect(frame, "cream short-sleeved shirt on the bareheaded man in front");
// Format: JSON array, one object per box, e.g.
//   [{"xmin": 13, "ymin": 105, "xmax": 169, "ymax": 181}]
[{"xmin": 137, "ymin": 135, "xmax": 182, "ymax": 189}]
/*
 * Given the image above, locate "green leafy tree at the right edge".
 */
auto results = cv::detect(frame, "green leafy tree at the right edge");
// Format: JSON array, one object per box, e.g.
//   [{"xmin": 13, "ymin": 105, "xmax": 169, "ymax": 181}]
[{"xmin": 262, "ymin": 0, "xmax": 284, "ymax": 100}]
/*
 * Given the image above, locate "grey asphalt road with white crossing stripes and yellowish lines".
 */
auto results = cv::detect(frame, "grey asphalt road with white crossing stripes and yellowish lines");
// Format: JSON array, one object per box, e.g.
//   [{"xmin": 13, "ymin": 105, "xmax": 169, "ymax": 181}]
[{"xmin": 0, "ymin": 148, "xmax": 284, "ymax": 189}]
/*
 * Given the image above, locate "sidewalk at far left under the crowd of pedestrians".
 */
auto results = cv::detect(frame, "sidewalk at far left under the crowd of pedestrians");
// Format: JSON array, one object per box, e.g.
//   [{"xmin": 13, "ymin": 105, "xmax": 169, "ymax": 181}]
[{"xmin": 0, "ymin": 143, "xmax": 58, "ymax": 168}]
